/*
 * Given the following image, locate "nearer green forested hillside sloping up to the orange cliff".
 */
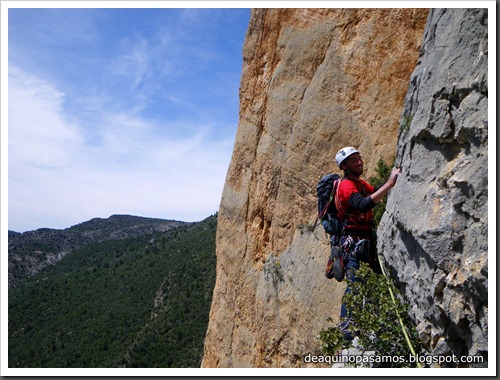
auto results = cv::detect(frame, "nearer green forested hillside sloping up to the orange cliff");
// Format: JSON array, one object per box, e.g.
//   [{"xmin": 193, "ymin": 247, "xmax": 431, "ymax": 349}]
[{"xmin": 8, "ymin": 215, "xmax": 217, "ymax": 368}]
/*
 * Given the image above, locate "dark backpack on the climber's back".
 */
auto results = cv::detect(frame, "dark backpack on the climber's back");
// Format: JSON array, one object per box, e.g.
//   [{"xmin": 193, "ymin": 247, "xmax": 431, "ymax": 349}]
[{"xmin": 316, "ymin": 174, "xmax": 343, "ymax": 245}]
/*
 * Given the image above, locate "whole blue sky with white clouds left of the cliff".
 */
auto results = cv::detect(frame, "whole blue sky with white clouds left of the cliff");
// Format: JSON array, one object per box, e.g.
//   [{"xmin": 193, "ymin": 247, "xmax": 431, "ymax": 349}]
[{"xmin": 2, "ymin": 2, "xmax": 250, "ymax": 232}]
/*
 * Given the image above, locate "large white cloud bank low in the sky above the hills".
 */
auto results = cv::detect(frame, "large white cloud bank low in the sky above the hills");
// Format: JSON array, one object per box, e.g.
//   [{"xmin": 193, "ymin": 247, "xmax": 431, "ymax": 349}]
[{"xmin": 9, "ymin": 68, "xmax": 233, "ymax": 231}]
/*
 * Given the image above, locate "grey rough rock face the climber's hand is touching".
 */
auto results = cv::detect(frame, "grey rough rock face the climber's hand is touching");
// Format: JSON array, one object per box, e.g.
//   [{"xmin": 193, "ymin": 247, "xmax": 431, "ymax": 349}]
[{"xmin": 378, "ymin": 9, "xmax": 488, "ymax": 362}]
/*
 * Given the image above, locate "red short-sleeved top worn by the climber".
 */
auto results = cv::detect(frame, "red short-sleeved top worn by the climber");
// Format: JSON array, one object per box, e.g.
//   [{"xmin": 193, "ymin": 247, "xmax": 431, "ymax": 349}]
[{"xmin": 335, "ymin": 178, "xmax": 375, "ymax": 236}]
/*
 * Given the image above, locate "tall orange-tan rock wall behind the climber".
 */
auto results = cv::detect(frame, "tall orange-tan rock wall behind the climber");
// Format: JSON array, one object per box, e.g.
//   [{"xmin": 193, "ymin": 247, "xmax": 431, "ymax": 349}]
[{"xmin": 203, "ymin": 9, "xmax": 428, "ymax": 367}]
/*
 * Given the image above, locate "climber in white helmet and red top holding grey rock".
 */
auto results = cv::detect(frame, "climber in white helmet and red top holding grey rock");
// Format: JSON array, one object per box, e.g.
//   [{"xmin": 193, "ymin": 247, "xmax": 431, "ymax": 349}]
[{"xmin": 334, "ymin": 147, "xmax": 401, "ymax": 339}]
